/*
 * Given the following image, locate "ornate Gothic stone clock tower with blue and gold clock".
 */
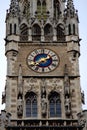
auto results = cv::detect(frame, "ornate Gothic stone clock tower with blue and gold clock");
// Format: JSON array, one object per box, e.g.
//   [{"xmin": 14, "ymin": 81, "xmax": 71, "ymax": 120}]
[{"xmin": 0, "ymin": 0, "xmax": 85, "ymax": 130}]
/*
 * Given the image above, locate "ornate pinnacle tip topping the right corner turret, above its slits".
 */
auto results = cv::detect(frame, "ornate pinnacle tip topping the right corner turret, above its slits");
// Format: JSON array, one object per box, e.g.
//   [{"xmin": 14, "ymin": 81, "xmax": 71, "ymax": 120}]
[{"xmin": 66, "ymin": 0, "xmax": 75, "ymax": 17}]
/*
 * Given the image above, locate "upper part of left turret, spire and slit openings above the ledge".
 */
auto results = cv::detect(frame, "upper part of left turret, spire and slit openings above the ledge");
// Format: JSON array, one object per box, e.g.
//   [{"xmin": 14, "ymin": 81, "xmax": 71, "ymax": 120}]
[{"xmin": 6, "ymin": 0, "xmax": 19, "ymax": 41}]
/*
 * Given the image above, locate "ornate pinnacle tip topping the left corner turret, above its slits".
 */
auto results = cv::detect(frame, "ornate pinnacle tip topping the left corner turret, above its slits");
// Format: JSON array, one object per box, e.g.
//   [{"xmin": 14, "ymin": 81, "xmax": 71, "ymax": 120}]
[{"xmin": 9, "ymin": 0, "xmax": 19, "ymax": 17}]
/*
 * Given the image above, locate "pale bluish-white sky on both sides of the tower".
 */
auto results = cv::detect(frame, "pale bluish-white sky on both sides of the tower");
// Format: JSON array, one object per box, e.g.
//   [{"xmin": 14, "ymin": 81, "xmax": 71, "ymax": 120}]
[{"xmin": 0, "ymin": 0, "xmax": 87, "ymax": 110}]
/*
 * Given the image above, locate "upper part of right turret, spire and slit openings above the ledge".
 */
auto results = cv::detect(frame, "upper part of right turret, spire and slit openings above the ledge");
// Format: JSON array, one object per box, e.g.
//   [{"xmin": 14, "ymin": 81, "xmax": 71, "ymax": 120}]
[{"xmin": 65, "ymin": 0, "xmax": 79, "ymax": 40}]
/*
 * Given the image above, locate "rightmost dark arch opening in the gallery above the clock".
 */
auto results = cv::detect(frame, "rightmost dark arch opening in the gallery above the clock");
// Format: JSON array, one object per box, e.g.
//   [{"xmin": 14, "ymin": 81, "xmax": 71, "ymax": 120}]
[{"xmin": 57, "ymin": 25, "xmax": 65, "ymax": 41}]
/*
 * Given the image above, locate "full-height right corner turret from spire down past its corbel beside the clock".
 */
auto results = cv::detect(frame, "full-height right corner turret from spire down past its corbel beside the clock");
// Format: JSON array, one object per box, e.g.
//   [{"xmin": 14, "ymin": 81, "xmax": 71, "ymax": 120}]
[{"xmin": 64, "ymin": 0, "xmax": 80, "ymax": 75}]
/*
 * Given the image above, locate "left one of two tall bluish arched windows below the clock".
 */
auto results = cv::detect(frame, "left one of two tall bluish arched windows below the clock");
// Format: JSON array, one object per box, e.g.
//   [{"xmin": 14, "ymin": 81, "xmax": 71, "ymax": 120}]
[{"xmin": 25, "ymin": 92, "xmax": 37, "ymax": 117}]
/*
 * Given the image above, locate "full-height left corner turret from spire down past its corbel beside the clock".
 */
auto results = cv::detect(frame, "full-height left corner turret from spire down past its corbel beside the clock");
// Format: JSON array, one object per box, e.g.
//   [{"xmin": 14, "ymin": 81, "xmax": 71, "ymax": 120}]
[{"xmin": 5, "ymin": 0, "xmax": 19, "ymax": 75}]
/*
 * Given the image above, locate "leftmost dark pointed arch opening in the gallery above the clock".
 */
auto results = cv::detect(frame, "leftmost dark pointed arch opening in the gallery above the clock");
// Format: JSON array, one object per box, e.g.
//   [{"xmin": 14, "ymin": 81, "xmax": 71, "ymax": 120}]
[{"xmin": 20, "ymin": 23, "xmax": 28, "ymax": 42}]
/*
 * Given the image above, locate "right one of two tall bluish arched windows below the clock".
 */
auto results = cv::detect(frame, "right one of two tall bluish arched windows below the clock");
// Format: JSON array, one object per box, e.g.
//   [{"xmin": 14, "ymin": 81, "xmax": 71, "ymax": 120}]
[{"xmin": 49, "ymin": 92, "xmax": 61, "ymax": 117}]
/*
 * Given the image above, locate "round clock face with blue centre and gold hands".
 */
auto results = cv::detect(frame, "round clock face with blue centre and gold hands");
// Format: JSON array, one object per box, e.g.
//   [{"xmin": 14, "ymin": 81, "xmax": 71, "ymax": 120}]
[{"xmin": 27, "ymin": 49, "xmax": 59, "ymax": 73}]
